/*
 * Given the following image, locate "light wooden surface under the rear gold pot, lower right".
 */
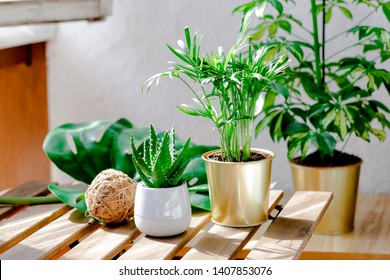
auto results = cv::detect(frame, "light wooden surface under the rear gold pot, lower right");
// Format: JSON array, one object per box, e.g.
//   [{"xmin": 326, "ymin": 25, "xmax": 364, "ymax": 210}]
[{"xmin": 301, "ymin": 194, "xmax": 390, "ymax": 260}]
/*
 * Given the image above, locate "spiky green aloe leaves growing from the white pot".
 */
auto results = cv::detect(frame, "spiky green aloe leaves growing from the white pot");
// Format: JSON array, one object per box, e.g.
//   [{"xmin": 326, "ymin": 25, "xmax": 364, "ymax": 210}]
[{"xmin": 131, "ymin": 125, "xmax": 191, "ymax": 188}]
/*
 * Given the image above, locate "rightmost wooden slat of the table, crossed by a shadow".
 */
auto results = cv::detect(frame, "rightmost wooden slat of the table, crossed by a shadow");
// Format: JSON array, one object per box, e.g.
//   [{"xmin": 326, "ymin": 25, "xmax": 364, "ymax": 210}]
[{"xmin": 247, "ymin": 191, "xmax": 333, "ymax": 259}]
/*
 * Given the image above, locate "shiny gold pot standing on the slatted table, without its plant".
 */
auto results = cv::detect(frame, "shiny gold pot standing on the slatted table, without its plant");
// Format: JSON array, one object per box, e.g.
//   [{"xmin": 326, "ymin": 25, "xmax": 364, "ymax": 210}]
[{"xmin": 203, "ymin": 149, "xmax": 275, "ymax": 227}]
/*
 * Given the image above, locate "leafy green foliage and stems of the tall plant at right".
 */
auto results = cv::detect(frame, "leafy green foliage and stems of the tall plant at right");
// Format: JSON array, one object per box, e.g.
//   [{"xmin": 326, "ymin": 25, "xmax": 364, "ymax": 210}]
[{"xmin": 234, "ymin": 0, "xmax": 390, "ymax": 159}]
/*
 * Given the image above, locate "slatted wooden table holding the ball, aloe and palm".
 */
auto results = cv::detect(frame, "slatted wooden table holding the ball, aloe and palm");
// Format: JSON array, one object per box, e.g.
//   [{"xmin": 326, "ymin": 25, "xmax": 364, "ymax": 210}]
[{"xmin": 0, "ymin": 183, "xmax": 332, "ymax": 260}]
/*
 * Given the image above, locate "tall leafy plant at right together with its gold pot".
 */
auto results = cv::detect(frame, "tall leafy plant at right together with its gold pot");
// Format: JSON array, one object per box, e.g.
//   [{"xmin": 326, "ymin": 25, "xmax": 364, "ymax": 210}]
[{"xmin": 234, "ymin": 0, "xmax": 390, "ymax": 234}]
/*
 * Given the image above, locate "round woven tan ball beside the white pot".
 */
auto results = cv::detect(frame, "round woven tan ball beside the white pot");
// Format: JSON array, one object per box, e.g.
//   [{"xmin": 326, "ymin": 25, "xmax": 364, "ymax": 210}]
[{"xmin": 85, "ymin": 169, "xmax": 137, "ymax": 224}]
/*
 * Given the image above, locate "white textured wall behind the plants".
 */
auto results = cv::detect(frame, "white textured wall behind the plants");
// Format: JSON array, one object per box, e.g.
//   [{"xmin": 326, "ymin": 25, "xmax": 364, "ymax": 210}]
[{"xmin": 47, "ymin": 0, "xmax": 390, "ymax": 193}]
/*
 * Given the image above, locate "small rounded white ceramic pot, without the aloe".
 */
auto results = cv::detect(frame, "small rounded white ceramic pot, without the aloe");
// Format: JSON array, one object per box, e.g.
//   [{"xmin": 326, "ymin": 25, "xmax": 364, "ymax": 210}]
[{"xmin": 134, "ymin": 182, "xmax": 191, "ymax": 237}]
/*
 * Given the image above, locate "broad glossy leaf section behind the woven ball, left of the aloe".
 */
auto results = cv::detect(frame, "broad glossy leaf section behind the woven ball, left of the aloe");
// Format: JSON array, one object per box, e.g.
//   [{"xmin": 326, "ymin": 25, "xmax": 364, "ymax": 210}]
[{"xmin": 43, "ymin": 119, "xmax": 148, "ymax": 184}]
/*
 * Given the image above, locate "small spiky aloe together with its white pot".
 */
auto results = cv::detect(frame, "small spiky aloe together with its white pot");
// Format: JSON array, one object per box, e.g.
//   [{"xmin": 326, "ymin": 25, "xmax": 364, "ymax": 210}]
[{"xmin": 131, "ymin": 125, "xmax": 191, "ymax": 237}]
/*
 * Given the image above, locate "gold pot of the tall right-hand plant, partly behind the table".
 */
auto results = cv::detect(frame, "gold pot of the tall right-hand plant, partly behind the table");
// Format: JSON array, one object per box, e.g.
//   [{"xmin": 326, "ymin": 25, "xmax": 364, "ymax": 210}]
[{"xmin": 290, "ymin": 160, "xmax": 362, "ymax": 235}]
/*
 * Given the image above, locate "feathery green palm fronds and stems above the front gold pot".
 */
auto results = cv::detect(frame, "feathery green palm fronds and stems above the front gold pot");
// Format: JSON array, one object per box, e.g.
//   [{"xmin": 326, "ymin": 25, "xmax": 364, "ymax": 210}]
[{"xmin": 143, "ymin": 21, "xmax": 288, "ymax": 161}]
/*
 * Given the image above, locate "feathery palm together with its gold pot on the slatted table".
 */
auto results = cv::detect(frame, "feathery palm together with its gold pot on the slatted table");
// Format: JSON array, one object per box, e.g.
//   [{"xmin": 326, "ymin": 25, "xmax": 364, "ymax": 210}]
[{"xmin": 143, "ymin": 21, "xmax": 288, "ymax": 227}]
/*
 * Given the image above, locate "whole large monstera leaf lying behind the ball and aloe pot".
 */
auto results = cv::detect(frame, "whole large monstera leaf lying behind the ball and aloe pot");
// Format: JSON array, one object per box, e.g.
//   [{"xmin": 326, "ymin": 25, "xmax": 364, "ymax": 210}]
[{"xmin": 43, "ymin": 119, "xmax": 217, "ymax": 210}]
